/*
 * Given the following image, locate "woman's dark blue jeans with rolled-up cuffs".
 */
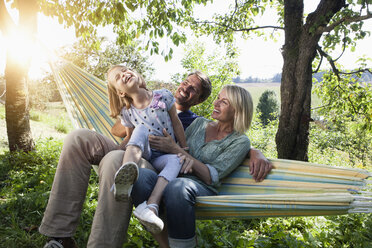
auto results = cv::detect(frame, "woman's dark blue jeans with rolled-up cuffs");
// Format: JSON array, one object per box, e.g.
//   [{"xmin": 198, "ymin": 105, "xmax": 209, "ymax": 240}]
[{"xmin": 131, "ymin": 168, "xmax": 216, "ymax": 240}]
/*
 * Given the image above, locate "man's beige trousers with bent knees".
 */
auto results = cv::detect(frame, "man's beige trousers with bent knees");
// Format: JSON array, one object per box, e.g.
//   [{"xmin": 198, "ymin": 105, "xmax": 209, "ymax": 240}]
[{"xmin": 39, "ymin": 129, "xmax": 151, "ymax": 247}]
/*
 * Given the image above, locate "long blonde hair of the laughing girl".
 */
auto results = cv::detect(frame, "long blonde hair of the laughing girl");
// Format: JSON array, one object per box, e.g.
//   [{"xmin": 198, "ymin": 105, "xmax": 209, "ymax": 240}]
[{"xmin": 107, "ymin": 65, "xmax": 147, "ymax": 118}]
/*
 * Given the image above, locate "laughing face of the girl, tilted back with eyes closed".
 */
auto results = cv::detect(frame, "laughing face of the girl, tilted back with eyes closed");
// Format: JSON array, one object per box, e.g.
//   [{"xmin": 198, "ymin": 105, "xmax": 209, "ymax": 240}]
[{"xmin": 107, "ymin": 67, "xmax": 139, "ymax": 97}]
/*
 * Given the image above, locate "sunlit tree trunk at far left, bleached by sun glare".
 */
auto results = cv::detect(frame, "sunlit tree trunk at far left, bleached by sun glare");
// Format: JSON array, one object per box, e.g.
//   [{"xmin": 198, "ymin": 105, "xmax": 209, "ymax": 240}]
[{"xmin": 5, "ymin": 0, "xmax": 37, "ymax": 151}]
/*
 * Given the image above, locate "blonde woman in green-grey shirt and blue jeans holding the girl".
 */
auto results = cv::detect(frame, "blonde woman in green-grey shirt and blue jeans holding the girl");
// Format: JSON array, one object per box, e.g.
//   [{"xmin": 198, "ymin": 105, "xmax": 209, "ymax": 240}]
[{"xmin": 132, "ymin": 85, "xmax": 253, "ymax": 247}]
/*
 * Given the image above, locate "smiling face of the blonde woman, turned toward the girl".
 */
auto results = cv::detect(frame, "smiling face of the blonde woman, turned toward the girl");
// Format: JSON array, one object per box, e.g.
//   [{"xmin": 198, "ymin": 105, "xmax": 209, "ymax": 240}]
[{"xmin": 212, "ymin": 89, "xmax": 235, "ymax": 123}]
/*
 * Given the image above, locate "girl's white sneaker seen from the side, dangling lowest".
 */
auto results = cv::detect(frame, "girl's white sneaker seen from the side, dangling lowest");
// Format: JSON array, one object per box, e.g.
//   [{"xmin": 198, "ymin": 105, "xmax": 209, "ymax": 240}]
[{"xmin": 133, "ymin": 202, "xmax": 164, "ymax": 234}]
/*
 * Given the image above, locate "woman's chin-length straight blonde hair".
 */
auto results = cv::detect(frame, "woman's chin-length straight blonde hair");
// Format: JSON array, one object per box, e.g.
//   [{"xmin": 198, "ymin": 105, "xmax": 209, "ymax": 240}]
[{"xmin": 223, "ymin": 84, "xmax": 253, "ymax": 134}]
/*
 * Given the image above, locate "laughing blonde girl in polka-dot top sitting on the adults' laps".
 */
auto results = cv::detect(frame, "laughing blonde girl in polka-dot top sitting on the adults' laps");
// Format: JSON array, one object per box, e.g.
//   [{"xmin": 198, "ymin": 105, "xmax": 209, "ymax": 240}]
[{"xmin": 107, "ymin": 65, "xmax": 186, "ymax": 233}]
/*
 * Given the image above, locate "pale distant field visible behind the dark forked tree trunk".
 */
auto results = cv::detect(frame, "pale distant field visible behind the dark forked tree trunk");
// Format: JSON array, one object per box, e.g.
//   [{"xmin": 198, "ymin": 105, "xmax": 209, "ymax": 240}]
[{"xmin": 237, "ymin": 83, "xmax": 321, "ymax": 109}]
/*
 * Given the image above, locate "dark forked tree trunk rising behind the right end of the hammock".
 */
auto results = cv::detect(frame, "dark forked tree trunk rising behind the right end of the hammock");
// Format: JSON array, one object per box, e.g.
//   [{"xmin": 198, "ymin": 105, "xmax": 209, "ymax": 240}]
[{"xmin": 276, "ymin": 0, "xmax": 345, "ymax": 161}]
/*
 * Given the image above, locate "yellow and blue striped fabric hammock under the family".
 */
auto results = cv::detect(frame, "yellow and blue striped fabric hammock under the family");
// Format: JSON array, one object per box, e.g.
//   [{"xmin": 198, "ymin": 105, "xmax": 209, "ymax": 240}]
[{"xmin": 51, "ymin": 58, "xmax": 372, "ymax": 219}]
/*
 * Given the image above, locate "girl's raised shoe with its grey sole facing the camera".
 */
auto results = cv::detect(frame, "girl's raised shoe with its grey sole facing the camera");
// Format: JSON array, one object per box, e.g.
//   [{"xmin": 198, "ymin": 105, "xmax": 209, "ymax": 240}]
[{"xmin": 112, "ymin": 162, "xmax": 138, "ymax": 201}]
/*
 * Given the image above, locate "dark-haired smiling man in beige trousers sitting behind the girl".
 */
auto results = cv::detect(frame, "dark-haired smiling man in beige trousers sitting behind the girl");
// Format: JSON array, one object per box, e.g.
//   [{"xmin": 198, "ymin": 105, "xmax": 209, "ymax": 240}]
[{"xmin": 39, "ymin": 72, "xmax": 271, "ymax": 248}]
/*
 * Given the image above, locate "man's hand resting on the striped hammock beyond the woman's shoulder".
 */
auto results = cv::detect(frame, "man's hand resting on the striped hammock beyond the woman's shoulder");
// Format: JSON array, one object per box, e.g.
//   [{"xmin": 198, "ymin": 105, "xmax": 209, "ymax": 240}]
[{"xmin": 249, "ymin": 148, "xmax": 273, "ymax": 182}]
